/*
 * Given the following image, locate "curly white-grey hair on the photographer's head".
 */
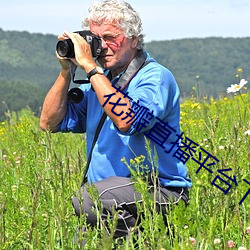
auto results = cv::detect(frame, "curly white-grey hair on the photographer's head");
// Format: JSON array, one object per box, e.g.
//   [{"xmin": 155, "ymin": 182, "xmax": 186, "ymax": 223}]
[{"xmin": 82, "ymin": 0, "xmax": 144, "ymax": 49}]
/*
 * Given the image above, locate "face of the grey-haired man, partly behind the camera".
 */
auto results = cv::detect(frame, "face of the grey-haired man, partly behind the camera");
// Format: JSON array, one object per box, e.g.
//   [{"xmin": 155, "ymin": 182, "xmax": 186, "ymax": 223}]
[{"xmin": 90, "ymin": 21, "xmax": 137, "ymax": 73}]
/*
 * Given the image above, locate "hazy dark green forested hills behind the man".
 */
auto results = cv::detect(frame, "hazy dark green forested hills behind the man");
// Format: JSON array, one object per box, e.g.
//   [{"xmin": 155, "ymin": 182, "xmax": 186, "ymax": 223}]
[{"xmin": 0, "ymin": 29, "xmax": 250, "ymax": 120}]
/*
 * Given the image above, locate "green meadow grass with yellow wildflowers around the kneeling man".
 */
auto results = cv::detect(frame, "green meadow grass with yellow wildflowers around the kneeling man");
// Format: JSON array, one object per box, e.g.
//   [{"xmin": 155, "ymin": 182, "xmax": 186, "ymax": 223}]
[{"xmin": 0, "ymin": 94, "xmax": 250, "ymax": 250}]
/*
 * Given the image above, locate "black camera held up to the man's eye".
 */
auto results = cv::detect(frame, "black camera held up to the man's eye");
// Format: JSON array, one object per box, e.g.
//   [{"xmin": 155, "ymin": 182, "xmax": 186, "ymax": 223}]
[{"xmin": 56, "ymin": 30, "xmax": 102, "ymax": 58}]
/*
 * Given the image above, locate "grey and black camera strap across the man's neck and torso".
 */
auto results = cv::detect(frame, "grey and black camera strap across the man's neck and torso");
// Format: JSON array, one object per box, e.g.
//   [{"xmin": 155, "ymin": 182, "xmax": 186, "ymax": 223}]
[{"xmin": 81, "ymin": 50, "xmax": 150, "ymax": 186}]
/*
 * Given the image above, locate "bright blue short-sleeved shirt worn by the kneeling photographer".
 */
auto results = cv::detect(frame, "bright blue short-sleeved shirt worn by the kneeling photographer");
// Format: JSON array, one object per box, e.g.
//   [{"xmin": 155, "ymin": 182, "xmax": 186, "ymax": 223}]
[{"xmin": 58, "ymin": 51, "xmax": 191, "ymax": 187}]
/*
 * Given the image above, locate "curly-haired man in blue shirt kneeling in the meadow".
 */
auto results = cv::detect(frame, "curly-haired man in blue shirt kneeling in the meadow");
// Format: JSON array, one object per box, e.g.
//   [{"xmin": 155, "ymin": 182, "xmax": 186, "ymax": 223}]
[{"xmin": 40, "ymin": 0, "xmax": 191, "ymax": 242}]
